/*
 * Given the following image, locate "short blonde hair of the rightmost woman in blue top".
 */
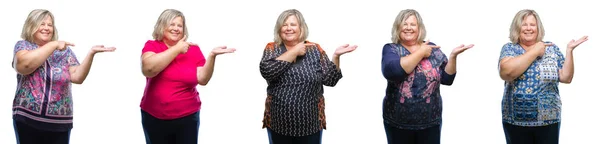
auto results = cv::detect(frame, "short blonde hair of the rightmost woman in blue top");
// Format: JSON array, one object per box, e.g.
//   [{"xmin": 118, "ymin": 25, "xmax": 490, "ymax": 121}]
[{"xmin": 509, "ymin": 9, "xmax": 546, "ymax": 43}]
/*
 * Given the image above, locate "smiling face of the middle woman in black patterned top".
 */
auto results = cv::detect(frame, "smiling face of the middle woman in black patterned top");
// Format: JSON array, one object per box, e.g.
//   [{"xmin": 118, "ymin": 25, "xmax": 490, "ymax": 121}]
[{"xmin": 279, "ymin": 15, "xmax": 301, "ymax": 42}]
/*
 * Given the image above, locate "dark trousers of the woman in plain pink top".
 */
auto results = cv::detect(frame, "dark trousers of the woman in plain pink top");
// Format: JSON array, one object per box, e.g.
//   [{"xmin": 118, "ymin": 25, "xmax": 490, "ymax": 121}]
[{"xmin": 142, "ymin": 110, "xmax": 200, "ymax": 144}]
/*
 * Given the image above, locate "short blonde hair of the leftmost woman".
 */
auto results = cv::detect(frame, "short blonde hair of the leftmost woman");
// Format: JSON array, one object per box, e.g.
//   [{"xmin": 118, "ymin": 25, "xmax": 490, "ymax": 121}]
[{"xmin": 21, "ymin": 9, "xmax": 58, "ymax": 42}]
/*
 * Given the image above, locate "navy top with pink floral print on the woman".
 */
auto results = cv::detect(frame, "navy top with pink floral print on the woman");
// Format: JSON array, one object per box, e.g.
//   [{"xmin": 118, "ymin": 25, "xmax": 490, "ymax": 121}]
[{"xmin": 381, "ymin": 43, "xmax": 456, "ymax": 130}]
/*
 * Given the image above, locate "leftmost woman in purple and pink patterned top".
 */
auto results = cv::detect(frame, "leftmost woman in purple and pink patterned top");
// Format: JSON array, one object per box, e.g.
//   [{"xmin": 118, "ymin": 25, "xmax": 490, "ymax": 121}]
[{"xmin": 13, "ymin": 9, "xmax": 115, "ymax": 144}]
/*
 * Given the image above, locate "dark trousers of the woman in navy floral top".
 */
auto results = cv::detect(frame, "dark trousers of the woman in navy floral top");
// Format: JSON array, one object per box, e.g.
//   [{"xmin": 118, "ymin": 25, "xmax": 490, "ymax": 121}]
[{"xmin": 383, "ymin": 123, "xmax": 442, "ymax": 144}]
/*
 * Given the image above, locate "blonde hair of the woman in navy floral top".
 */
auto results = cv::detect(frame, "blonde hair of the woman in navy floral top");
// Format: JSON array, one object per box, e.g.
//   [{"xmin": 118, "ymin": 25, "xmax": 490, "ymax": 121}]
[{"xmin": 392, "ymin": 9, "xmax": 427, "ymax": 44}]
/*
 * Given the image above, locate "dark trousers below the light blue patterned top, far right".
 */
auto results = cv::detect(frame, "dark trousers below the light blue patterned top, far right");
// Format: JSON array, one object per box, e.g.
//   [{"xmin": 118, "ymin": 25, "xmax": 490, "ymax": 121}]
[{"xmin": 502, "ymin": 122, "xmax": 560, "ymax": 144}]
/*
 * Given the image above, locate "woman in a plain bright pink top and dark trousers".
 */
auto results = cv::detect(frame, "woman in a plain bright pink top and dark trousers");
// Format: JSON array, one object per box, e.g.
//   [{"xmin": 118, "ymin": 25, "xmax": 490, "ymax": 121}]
[{"xmin": 140, "ymin": 9, "xmax": 235, "ymax": 144}]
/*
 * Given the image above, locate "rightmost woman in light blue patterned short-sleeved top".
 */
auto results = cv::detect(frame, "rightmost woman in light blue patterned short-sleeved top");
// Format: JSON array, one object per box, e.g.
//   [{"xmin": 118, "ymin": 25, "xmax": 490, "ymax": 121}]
[{"xmin": 498, "ymin": 9, "xmax": 587, "ymax": 144}]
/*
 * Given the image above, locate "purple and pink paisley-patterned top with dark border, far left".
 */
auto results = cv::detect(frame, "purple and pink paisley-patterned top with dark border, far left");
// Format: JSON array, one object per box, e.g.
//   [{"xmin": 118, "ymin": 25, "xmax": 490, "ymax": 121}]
[{"xmin": 13, "ymin": 40, "xmax": 79, "ymax": 130}]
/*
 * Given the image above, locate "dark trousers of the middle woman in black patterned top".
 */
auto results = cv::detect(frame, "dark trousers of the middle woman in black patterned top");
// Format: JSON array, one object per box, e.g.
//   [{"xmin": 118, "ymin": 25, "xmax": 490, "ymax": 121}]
[{"xmin": 267, "ymin": 128, "xmax": 323, "ymax": 144}]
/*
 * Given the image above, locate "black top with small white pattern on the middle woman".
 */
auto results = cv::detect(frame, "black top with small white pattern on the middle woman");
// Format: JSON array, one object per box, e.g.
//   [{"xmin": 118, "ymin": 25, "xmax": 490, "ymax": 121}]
[{"xmin": 260, "ymin": 42, "xmax": 342, "ymax": 136}]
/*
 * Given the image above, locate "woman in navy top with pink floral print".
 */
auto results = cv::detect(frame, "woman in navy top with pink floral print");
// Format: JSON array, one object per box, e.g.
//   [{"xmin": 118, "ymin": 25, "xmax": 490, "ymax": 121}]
[{"xmin": 381, "ymin": 9, "xmax": 473, "ymax": 144}]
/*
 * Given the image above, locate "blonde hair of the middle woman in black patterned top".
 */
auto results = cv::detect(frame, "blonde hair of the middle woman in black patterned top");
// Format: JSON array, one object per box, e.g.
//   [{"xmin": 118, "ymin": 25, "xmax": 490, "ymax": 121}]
[{"xmin": 274, "ymin": 9, "xmax": 308, "ymax": 45}]
